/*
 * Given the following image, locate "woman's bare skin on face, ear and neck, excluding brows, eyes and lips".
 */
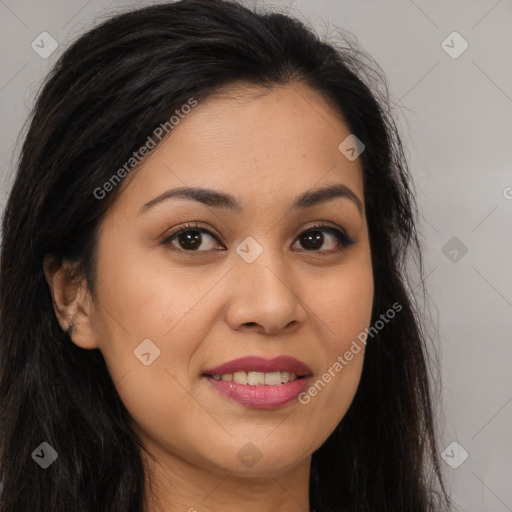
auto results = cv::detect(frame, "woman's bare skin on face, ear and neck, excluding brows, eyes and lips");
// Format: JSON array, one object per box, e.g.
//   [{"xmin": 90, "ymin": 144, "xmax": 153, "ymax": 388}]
[{"xmin": 45, "ymin": 83, "xmax": 373, "ymax": 512}]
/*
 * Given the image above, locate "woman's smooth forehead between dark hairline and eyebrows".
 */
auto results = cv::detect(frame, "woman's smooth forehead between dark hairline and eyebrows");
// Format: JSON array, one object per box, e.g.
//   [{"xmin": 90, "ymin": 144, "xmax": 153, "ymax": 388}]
[{"xmin": 112, "ymin": 84, "xmax": 363, "ymax": 213}]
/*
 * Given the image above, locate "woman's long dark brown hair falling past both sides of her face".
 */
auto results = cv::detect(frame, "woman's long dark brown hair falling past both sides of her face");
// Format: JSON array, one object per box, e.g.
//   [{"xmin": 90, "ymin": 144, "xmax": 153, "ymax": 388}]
[{"xmin": 0, "ymin": 0, "xmax": 449, "ymax": 512}]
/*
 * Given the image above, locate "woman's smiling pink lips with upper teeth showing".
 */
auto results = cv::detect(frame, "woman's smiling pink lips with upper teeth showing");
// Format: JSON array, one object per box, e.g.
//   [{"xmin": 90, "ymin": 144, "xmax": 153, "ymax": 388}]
[{"xmin": 203, "ymin": 356, "xmax": 311, "ymax": 409}]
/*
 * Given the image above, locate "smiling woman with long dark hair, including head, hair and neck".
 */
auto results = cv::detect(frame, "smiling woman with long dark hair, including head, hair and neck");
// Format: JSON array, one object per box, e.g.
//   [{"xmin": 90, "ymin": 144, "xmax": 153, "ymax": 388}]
[{"xmin": 0, "ymin": 0, "xmax": 449, "ymax": 512}]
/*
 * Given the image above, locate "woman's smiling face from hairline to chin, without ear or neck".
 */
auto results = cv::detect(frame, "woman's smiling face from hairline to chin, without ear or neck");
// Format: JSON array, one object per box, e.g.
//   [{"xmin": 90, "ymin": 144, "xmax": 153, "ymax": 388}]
[{"xmin": 83, "ymin": 84, "xmax": 373, "ymax": 476}]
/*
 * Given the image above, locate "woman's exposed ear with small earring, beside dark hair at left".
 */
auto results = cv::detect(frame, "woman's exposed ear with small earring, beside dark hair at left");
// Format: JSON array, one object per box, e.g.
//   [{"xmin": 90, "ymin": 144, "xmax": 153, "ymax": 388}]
[{"xmin": 43, "ymin": 254, "xmax": 98, "ymax": 349}]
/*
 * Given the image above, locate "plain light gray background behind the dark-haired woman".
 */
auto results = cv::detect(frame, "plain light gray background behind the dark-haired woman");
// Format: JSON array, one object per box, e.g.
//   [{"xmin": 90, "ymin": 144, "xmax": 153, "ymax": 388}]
[{"xmin": 0, "ymin": 0, "xmax": 512, "ymax": 512}]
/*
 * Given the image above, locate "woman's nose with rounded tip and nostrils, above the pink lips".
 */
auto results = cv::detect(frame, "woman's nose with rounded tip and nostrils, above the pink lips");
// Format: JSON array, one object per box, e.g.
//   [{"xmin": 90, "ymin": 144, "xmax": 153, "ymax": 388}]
[{"xmin": 226, "ymin": 250, "xmax": 306, "ymax": 335}]
